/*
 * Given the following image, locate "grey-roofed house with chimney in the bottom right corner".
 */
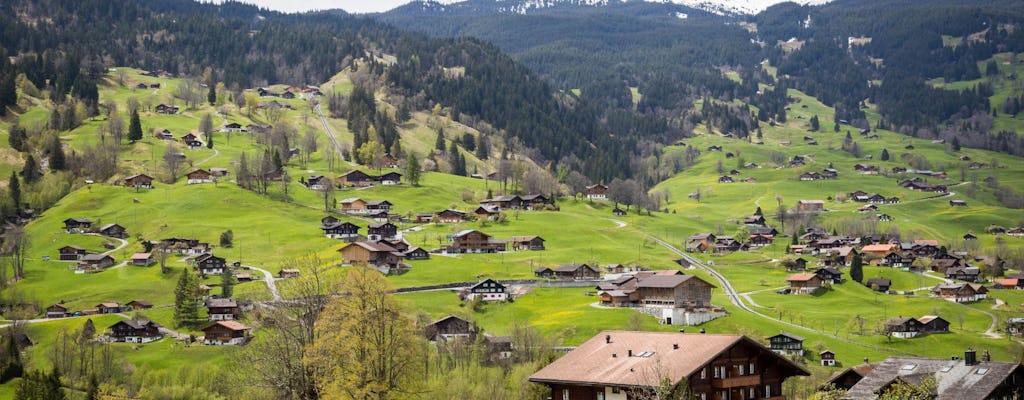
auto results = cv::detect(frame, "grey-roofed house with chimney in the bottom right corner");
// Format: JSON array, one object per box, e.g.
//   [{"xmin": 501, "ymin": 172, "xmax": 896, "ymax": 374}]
[{"xmin": 843, "ymin": 350, "xmax": 1024, "ymax": 400}]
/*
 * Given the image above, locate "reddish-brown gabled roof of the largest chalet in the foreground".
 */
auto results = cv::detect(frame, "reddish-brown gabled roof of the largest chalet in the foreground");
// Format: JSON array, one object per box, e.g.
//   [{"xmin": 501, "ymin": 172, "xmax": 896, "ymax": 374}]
[{"xmin": 529, "ymin": 330, "xmax": 810, "ymax": 387}]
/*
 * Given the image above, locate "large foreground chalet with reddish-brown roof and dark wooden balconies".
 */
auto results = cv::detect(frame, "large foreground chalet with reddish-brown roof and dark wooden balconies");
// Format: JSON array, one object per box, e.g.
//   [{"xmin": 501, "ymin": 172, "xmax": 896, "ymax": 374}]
[{"xmin": 529, "ymin": 330, "xmax": 810, "ymax": 400}]
